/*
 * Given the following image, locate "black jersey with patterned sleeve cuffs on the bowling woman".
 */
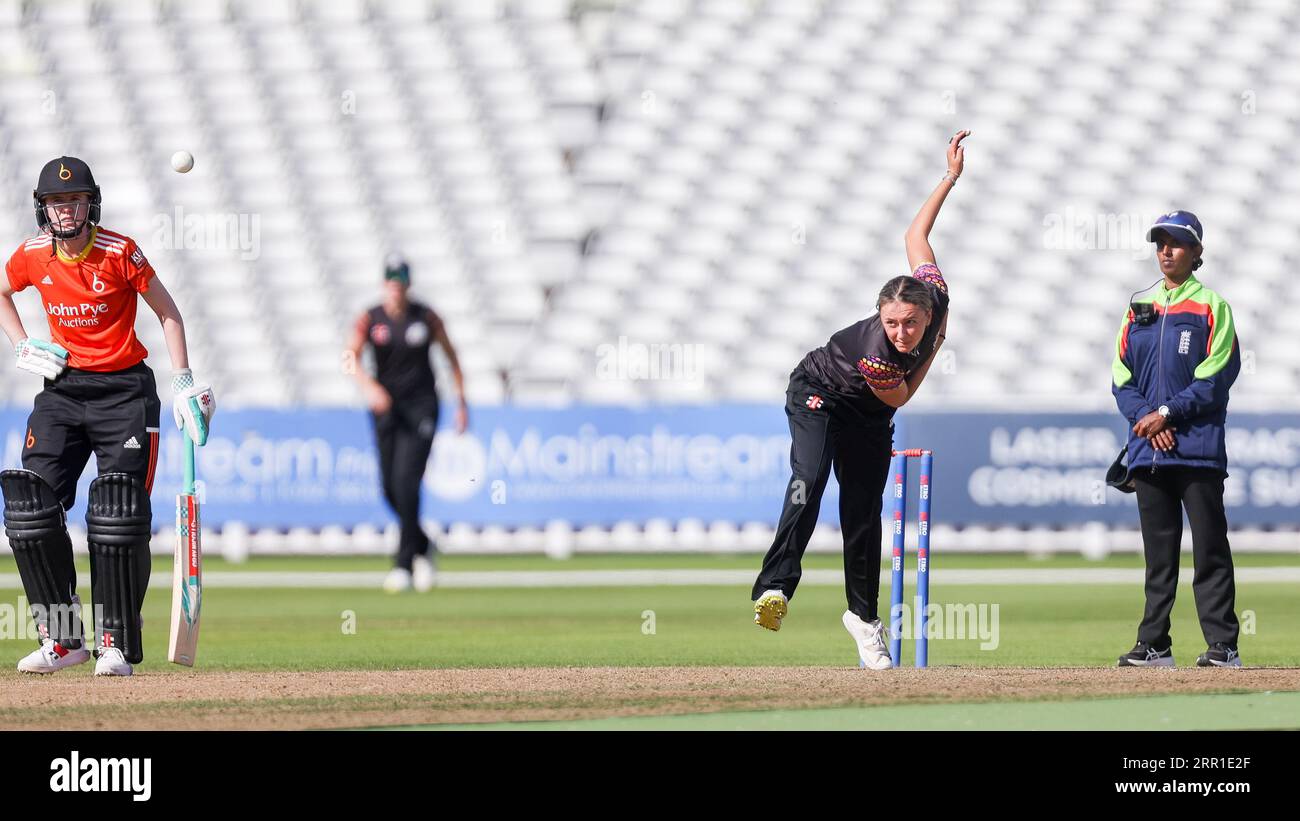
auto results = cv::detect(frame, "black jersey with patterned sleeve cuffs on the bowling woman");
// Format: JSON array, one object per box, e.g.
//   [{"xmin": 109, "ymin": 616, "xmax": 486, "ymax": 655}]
[{"xmin": 800, "ymin": 262, "xmax": 948, "ymax": 416}]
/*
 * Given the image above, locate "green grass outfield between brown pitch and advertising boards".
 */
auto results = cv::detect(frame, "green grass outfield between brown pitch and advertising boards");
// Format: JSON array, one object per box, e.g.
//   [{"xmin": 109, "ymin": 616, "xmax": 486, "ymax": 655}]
[{"xmin": 0, "ymin": 553, "xmax": 1300, "ymax": 672}]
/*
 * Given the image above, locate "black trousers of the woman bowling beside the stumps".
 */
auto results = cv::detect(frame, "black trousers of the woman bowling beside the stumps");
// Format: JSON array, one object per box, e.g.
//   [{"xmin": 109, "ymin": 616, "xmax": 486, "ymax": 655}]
[{"xmin": 753, "ymin": 370, "xmax": 893, "ymax": 621}]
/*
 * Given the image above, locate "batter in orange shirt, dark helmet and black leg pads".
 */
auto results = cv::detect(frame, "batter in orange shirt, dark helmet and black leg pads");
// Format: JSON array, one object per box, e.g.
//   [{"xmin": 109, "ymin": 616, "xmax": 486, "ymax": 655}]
[{"xmin": 0, "ymin": 157, "xmax": 216, "ymax": 676}]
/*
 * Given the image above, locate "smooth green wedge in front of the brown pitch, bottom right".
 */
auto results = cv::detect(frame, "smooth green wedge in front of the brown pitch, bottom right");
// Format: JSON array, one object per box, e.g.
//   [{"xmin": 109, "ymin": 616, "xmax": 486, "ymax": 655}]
[{"xmin": 397, "ymin": 692, "xmax": 1300, "ymax": 731}]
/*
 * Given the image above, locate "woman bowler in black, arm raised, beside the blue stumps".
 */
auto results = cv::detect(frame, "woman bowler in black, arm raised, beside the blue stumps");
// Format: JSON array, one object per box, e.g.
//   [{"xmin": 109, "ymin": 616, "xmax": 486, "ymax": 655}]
[{"xmin": 753, "ymin": 131, "xmax": 970, "ymax": 669}]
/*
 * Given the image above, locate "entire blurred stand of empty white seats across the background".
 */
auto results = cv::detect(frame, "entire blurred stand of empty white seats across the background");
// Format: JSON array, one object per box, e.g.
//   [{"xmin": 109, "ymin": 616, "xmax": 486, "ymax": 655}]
[{"xmin": 0, "ymin": 0, "xmax": 1300, "ymax": 409}]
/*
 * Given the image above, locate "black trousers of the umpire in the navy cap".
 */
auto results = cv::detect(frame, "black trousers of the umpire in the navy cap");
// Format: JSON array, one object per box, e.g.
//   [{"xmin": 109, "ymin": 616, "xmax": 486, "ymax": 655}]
[{"xmin": 1134, "ymin": 466, "xmax": 1239, "ymax": 648}]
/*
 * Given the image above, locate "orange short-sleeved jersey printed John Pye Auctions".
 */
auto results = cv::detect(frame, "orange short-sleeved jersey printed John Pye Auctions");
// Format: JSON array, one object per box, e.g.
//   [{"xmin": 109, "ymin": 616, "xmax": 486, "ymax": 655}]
[{"xmin": 5, "ymin": 226, "xmax": 153, "ymax": 372}]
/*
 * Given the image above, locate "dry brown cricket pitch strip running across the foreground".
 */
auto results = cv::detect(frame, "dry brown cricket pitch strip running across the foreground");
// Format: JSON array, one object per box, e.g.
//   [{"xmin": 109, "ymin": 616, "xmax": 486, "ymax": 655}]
[{"xmin": 0, "ymin": 666, "xmax": 1300, "ymax": 730}]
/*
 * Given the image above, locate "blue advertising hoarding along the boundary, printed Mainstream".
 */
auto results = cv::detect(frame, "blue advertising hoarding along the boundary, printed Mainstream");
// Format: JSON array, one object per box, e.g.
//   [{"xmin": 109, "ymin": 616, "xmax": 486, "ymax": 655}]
[{"xmin": 0, "ymin": 404, "xmax": 1300, "ymax": 527}]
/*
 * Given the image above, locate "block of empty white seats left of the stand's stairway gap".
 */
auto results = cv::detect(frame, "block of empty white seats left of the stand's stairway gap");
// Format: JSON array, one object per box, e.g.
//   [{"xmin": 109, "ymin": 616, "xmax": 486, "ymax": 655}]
[{"xmin": 0, "ymin": 0, "xmax": 599, "ymax": 407}]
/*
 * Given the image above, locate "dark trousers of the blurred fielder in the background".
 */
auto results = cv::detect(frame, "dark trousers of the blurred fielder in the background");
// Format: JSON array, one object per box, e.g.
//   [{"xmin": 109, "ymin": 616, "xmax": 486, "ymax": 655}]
[{"xmin": 371, "ymin": 398, "xmax": 438, "ymax": 570}]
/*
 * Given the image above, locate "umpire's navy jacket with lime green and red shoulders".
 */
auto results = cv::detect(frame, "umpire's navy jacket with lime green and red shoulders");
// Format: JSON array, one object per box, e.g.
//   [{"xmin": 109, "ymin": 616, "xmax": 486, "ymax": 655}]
[{"xmin": 1112, "ymin": 275, "xmax": 1242, "ymax": 475}]
